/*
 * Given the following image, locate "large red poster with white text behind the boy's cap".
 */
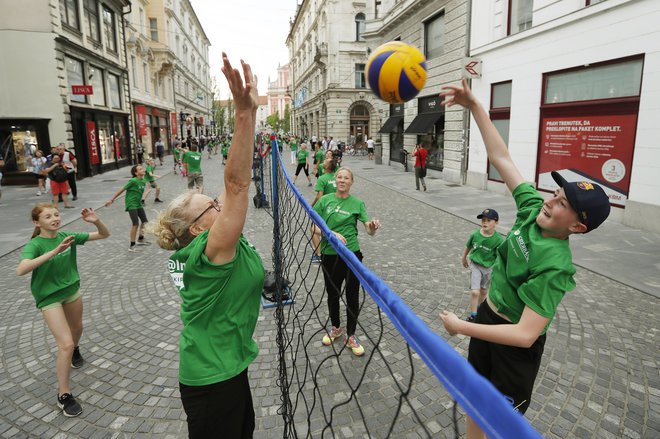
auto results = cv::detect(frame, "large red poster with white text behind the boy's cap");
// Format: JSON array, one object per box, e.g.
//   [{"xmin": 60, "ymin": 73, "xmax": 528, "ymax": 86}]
[{"xmin": 538, "ymin": 114, "xmax": 637, "ymax": 206}]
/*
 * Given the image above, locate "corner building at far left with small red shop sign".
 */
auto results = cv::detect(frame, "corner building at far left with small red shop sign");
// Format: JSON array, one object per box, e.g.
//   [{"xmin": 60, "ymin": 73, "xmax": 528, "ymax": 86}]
[{"xmin": 0, "ymin": 0, "xmax": 131, "ymax": 182}]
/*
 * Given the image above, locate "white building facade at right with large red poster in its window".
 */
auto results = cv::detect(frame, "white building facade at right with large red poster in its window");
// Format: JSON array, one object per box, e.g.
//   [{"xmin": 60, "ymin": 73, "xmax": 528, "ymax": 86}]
[{"xmin": 470, "ymin": 0, "xmax": 660, "ymax": 231}]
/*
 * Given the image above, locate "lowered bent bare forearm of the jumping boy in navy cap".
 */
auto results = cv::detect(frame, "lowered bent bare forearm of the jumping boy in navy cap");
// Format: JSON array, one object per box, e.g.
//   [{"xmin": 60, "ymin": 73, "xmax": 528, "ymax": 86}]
[{"xmin": 440, "ymin": 306, "xmax": 548, "ymax": 348}]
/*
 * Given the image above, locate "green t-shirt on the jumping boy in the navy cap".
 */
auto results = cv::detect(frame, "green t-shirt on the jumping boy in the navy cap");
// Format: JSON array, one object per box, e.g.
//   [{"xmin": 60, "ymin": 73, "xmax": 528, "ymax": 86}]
[{"xmin": 488, "ymin": 183, "xmax": 575, "ymax": 335}]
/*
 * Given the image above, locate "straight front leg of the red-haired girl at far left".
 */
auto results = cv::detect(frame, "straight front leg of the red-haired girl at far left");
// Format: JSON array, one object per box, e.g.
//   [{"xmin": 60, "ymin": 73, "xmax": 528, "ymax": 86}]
[{"xmin": 42, "ymin": 306, "xmax": 75, "ymax": 395}]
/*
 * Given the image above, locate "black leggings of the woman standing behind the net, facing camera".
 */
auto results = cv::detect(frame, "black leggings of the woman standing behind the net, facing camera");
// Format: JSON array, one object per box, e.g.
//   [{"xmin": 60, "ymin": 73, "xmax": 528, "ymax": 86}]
[{"xmin": 321, "ymin": 250, "xmax": 362, "ymax": 337}]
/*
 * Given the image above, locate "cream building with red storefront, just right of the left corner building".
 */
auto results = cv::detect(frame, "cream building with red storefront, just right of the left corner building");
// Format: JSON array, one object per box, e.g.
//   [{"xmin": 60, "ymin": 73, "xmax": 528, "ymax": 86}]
[{"xmin": 126, "ymin": 0, "xmax": 179, "ymax": 162}]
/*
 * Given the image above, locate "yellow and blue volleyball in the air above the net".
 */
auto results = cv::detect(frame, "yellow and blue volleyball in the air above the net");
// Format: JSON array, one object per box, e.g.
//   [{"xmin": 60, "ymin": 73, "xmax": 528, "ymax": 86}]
[{"xmin": 366, "ymin": 41, "xmax": 426, "ymax": 104}]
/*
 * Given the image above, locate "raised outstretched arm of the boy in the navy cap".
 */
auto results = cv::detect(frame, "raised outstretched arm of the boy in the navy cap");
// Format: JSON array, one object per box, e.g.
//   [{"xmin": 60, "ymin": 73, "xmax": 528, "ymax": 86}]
[{"xmin": 440, "ymin": 79, "xmax": 525, "ymax": 192}]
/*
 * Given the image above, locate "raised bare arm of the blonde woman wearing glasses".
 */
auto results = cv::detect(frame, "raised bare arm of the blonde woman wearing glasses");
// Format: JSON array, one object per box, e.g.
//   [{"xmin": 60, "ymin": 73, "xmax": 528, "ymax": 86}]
[{"xmin": 205, "ymin": 53, "xmax": 258, "ymax": 264}]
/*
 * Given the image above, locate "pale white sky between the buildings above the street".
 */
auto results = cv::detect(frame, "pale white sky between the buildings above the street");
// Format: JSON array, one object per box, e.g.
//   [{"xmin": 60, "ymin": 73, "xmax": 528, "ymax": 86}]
[{"xmin": 190, "ymin": 0, "xmax": 297, "ymax": 99}]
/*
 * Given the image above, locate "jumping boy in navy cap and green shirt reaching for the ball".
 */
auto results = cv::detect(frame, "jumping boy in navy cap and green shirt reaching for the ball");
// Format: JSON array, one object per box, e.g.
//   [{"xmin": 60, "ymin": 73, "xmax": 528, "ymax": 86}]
[{"xmin": 440, "ymin": 79, "xmax": 610, "ymax": 439}]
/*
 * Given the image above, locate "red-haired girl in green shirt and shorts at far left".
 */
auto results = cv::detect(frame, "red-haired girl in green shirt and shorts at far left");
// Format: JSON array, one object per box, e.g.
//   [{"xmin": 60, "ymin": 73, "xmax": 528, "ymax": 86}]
[{"xmin": 16, "ymin": 203, "xmax": 110, "ymax": 417}]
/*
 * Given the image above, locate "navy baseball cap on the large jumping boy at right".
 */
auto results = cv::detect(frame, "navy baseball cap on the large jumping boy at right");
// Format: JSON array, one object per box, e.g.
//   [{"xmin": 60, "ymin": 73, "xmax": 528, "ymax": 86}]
[{"xmin": 551, "ymin": 171, "xmax": 610, "ymax": 233}]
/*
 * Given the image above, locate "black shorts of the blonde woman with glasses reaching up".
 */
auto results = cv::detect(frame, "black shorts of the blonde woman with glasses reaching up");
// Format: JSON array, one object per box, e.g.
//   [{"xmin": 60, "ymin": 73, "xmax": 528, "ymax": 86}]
[{"xmin": 179, "ymin": 369, "xmax": 254, "ymax": 439}]
